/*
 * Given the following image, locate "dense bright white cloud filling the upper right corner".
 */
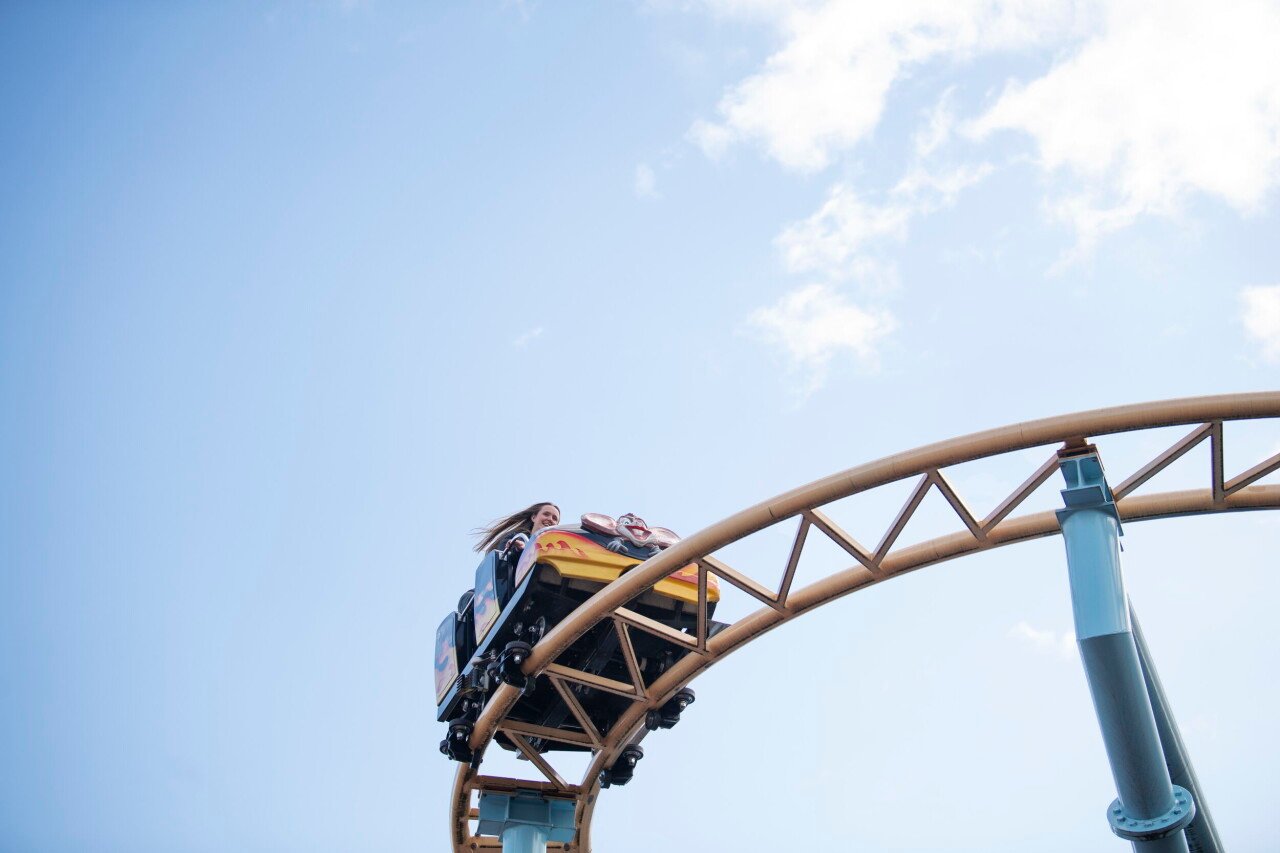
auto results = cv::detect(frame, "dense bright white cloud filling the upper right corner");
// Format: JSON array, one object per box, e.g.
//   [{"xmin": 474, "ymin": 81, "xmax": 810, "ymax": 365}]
[{"xmin": 969, "ymin": 0, "xmax": 1280, "ymax": 246}]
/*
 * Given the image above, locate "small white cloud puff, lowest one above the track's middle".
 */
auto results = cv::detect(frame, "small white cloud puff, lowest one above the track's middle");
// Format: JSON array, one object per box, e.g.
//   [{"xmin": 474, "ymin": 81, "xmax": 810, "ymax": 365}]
[{"xmin": 748, "ymin": 284, "xmax": 896, "ymax": 396}]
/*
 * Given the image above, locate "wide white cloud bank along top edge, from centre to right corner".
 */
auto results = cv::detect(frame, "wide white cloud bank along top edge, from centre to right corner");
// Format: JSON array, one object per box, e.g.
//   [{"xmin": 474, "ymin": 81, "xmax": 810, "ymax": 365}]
[{"xmin": 690, "ymin": 0, "xmax": 1280, "ymax": 251}]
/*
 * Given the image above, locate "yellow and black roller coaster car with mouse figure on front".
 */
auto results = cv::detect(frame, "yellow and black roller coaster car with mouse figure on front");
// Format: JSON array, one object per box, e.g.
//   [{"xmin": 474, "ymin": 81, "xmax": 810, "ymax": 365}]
[{"xmin": 435, "ymin": 512, "xmax": 721, "ymax": 765}]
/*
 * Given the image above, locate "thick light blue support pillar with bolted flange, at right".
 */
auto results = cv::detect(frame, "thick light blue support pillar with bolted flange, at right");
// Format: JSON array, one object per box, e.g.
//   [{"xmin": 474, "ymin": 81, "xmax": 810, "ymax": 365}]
[{"xmin": 1057, "ymin": 448, "xmax": 1196, "ymax": 853}]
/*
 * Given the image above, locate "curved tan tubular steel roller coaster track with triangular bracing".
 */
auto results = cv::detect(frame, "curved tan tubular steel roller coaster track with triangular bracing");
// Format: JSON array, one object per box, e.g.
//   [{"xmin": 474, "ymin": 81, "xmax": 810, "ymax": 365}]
[{"xmin": 449, "ymin": 392, "xmax": 1280, "ymax": 853}]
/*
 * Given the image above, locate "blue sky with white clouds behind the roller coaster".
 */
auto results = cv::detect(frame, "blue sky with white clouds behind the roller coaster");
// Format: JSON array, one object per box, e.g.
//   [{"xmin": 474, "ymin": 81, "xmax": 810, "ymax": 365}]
[{"xmin": 0, "ymin": 0, "xmax": 1280, "ymax": 853}]
